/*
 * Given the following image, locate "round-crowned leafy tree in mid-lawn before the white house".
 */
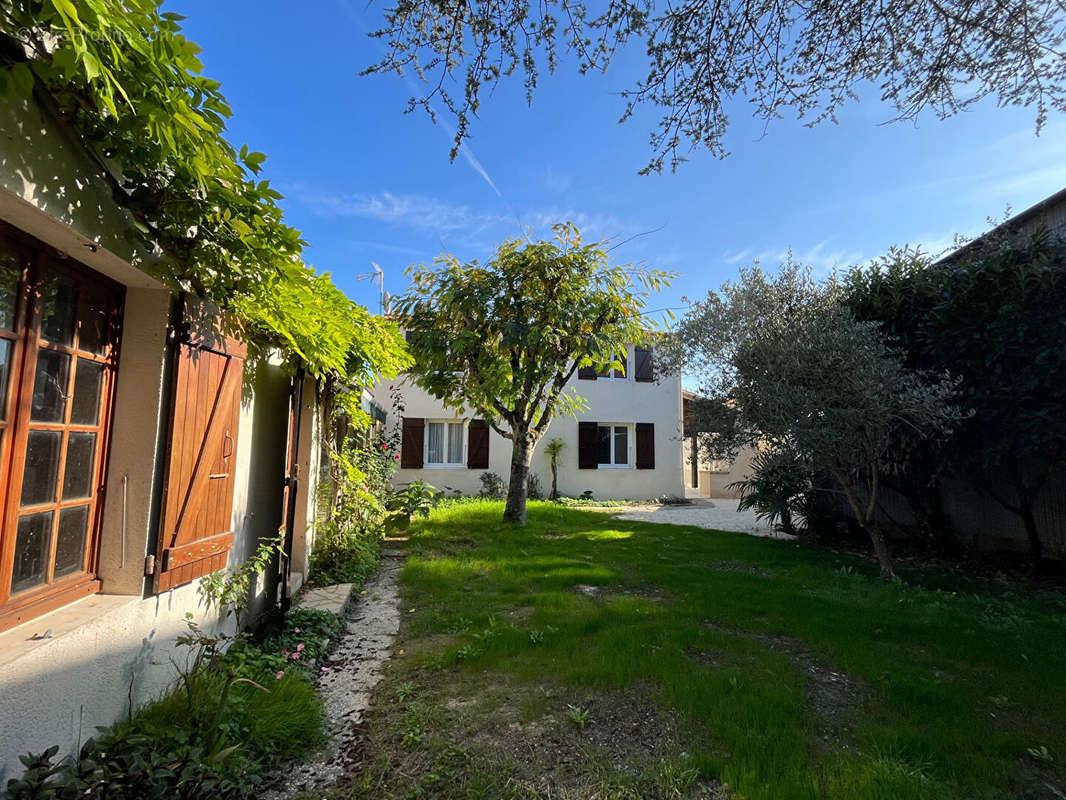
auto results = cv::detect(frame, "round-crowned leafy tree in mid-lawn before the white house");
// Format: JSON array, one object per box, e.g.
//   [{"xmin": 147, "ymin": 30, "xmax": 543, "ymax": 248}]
[{"xmin": 394, "ymin": 224, "xmax": 671, "ymax": 524}]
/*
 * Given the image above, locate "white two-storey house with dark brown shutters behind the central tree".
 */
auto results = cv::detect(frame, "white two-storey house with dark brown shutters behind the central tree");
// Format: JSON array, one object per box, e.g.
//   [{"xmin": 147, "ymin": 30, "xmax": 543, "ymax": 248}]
[{"xmin": 373, "ymin": 347, "xmax": 684, "ymax": 499}]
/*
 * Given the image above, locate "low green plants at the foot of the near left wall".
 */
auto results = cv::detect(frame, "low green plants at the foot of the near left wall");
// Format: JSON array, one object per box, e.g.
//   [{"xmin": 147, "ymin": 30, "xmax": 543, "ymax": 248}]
[{"xmin": 0, "ymin": 613, "xmax": 326, "ymax": 800}]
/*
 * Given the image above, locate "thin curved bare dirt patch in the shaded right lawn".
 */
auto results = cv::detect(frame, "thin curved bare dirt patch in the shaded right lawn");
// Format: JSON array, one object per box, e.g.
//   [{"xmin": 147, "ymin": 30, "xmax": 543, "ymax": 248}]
[{"xmin": 704, "ymin": 620, "xmax": 873, "ymax": 747}]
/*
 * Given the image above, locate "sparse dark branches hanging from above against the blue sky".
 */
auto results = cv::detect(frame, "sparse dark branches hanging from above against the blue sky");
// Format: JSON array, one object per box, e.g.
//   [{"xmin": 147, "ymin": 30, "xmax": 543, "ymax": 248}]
[{"xmin": 365, "ymin": 0, "xmax": 1066, "ymax": 172}]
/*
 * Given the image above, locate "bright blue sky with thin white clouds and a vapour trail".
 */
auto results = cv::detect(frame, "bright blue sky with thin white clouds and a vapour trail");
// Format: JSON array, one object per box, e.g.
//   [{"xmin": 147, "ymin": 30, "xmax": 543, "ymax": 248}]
[{"xmin": 167, "ymin": 0, "xmax": 1066, "ymax": 317}]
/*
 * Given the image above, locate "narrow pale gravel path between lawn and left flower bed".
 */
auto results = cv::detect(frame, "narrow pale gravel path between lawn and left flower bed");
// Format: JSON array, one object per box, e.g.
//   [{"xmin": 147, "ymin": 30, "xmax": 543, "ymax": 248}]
[{"xmin": 262, "ymin": 550, "xmax": 404, "ymax": 800}]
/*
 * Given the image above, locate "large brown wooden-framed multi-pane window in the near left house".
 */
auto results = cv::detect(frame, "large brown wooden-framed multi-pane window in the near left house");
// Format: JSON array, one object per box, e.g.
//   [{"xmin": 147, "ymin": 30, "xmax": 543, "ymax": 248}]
[{"xmin": 0, "ymin": 233, "xmax": 123, "ymax": 629}]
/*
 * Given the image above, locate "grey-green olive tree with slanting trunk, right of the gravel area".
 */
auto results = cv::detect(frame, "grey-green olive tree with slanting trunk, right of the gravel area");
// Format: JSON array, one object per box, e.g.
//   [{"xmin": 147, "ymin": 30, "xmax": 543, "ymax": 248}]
[{"xmin": 669, "ymin": 263, "xmax": 958, "ymax": 579}]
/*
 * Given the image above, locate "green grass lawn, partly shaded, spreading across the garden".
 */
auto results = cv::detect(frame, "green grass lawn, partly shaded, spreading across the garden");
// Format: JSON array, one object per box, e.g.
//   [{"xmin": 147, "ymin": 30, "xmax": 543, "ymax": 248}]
[{"xmin": 337, "ymin": 501, "xmax": 1066, "ymax": 800}]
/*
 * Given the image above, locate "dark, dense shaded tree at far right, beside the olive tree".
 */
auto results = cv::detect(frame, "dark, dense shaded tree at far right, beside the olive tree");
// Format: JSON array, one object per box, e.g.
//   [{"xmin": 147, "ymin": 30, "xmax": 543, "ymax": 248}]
[{"xmin": 844, "ymin": 235, "xmax": 1066, "ymax": 561}]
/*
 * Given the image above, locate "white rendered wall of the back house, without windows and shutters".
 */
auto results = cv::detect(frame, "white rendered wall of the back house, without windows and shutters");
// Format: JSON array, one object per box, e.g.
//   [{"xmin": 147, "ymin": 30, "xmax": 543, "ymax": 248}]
[{"xmin": 372, "ymin": 348, "xmax": 684, "ymax": 499}]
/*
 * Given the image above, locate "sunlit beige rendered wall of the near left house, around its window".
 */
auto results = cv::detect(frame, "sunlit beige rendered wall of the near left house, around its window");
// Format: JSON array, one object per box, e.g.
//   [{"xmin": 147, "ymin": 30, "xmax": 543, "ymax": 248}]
[{"xmin": 0, "ymin": 90, "xmax": 296, "ymax": 785}]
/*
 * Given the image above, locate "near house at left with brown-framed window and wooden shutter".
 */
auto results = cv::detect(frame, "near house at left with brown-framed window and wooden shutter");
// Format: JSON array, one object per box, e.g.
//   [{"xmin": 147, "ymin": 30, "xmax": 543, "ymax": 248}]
[{"xmin": 0, "ymin": 93, "xmax": 328, "ymax": 784}]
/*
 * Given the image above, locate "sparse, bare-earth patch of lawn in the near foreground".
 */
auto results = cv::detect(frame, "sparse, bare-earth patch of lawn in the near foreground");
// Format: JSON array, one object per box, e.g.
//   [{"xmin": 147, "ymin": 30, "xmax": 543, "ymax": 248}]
[{"xmin": 344, "ymin": 671, "xmax": 731, "ymax": 800}]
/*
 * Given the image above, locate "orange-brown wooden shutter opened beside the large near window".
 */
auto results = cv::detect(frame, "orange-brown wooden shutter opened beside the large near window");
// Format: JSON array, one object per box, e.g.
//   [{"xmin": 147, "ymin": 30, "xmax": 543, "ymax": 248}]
[{"xmin": 156, "ymin": 339, "xmax": 246, "ymax": 592}]
